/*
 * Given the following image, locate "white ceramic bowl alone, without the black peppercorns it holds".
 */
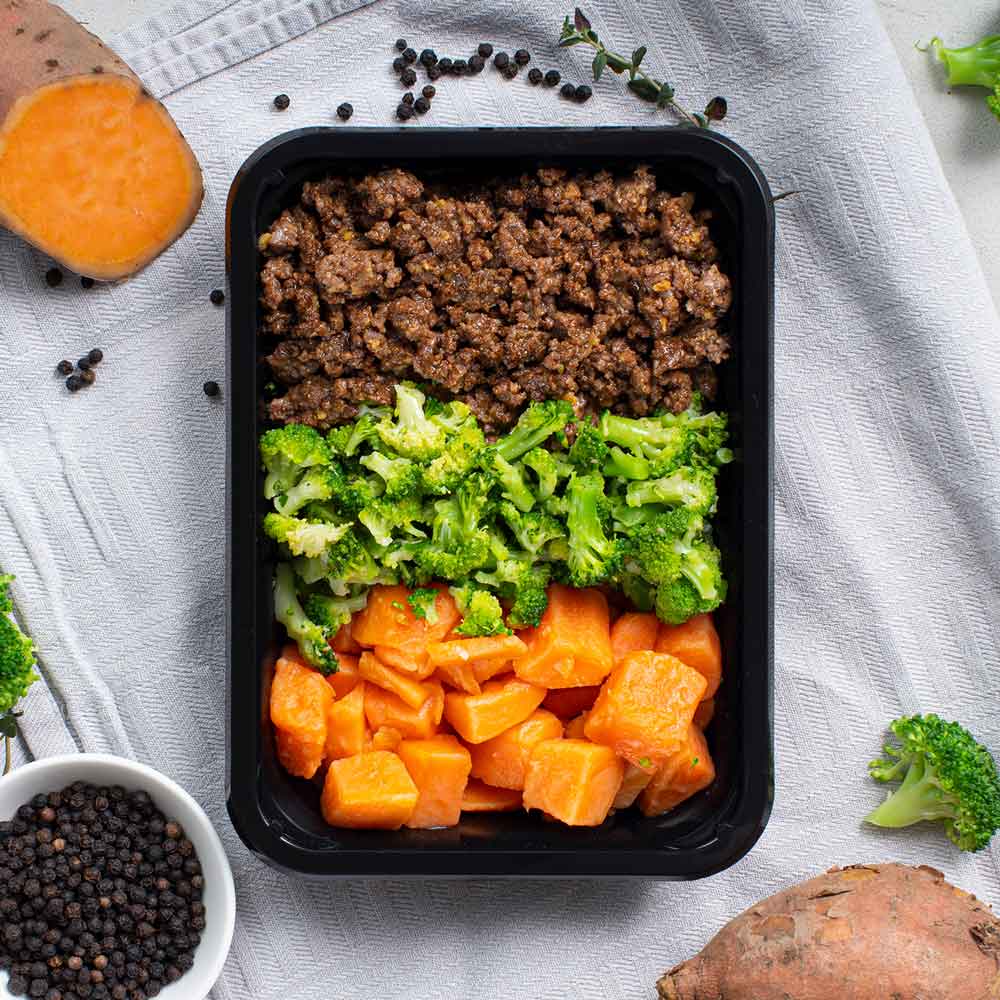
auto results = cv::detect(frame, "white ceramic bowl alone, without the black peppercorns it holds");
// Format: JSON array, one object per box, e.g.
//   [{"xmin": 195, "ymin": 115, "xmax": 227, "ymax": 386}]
[{"xmin": 0, "ymin": 753, "xmax": 236, "ymax": 1000}]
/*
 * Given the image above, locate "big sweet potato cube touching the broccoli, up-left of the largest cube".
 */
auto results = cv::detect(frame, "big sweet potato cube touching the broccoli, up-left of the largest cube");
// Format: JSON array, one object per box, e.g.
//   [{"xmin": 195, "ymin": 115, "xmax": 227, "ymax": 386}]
[{"xmin": 514, "ymin": 583, "xmax": 614, "ymax": 688}]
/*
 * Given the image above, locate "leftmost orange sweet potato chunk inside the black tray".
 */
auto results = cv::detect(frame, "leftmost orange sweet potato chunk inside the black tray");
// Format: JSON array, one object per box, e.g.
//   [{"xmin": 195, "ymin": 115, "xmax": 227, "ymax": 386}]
[{"xmin": 270, "ymin": 652, "xmax": 333, "ymax": 778}]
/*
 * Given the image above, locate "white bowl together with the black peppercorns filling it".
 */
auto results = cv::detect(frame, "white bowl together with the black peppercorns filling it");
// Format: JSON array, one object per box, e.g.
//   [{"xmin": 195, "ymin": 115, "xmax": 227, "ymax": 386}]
[{"xmin": 0, "ymin": 754, "xmax": 236, "ymax": 1000}]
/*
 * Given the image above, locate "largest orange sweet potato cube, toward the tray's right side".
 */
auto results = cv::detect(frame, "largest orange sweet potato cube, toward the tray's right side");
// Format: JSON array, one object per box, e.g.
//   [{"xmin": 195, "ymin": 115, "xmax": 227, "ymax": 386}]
[{"xmin": 584, "ymin": 651, "xmax": 706, "ymax": 767}]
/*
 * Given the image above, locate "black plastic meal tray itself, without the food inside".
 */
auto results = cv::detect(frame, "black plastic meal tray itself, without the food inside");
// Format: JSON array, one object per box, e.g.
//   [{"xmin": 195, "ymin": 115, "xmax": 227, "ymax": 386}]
[{"xmin": 226, "ymin": 127, "xmax": 774, "ymax": 879}]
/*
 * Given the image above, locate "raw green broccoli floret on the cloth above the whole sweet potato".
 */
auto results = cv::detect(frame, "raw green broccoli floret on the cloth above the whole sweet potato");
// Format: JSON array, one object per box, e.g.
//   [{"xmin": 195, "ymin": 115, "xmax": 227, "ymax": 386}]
[{"xmin": 865, "ymin": 715, "xmax": 1000, "ymax": 851}]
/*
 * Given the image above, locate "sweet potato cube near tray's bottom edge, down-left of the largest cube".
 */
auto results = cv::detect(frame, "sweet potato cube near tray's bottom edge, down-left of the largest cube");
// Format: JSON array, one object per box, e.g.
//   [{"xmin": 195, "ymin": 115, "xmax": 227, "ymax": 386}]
[{"xmin": 524, "ymin": 739, "xmax": 625, "ymax": 826}]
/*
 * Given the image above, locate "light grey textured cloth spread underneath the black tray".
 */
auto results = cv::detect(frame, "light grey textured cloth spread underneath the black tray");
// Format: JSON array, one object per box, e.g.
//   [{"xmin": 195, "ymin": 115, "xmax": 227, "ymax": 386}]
[{"xmin": 0, "ymin": 0, "xmax": 1000, "ymax": 1000}]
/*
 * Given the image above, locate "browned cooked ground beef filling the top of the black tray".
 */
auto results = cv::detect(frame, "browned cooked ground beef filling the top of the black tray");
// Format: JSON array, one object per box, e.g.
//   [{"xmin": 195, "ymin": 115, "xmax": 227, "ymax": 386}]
[{"xmin": 260, "ymin": 166, "xmax": 731, "ymax": 434}]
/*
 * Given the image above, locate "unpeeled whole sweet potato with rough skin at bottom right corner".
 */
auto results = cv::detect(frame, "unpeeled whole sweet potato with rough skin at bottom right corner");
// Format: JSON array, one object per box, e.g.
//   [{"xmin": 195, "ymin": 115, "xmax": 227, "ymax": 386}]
[{"xmin": 657, "ymin": 863, "xmax": 1000, "ymax": 1000}]
